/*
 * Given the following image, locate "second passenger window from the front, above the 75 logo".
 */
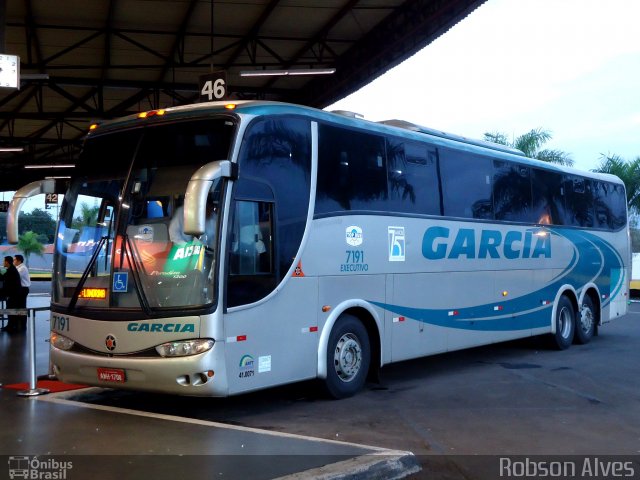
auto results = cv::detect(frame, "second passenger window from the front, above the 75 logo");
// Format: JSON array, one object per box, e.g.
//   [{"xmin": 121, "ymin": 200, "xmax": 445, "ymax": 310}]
[{"xmin": 387, "ymin": 138, "xmax": 440, "ymax": 215}]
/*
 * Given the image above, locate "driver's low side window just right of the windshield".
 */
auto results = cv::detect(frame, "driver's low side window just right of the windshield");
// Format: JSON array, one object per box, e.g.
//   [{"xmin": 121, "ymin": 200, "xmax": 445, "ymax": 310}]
[{"xmin": 227, "ymin": 200, "xmax": 277, "ymax": 307}]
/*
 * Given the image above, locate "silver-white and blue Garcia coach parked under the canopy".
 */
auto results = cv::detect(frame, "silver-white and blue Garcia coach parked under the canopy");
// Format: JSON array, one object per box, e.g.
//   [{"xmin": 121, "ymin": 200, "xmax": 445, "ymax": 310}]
[{"xmin": 9, "ymin": 101, "xmax": 630, "ymax": 398}]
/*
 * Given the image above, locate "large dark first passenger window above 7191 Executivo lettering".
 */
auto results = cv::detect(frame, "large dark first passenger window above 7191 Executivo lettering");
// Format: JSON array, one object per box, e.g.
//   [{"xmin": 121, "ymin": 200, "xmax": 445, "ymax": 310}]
[{"xmin": 316, "ymin": 125, "xmax": 387, "ymax": 213}]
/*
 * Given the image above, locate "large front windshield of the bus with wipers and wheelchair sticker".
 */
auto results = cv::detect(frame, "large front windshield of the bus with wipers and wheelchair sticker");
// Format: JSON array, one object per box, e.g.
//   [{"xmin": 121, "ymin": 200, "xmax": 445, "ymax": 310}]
[{"xmin": 52, "ymin": 118, "xmax": 235, "ymax": 315}]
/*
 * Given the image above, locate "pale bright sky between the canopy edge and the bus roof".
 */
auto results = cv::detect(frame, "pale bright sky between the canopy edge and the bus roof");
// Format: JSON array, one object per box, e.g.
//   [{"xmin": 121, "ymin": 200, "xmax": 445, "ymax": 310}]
[{"xmin": 326, "ymin": 0, "xmax": 640, "ymax": 170}]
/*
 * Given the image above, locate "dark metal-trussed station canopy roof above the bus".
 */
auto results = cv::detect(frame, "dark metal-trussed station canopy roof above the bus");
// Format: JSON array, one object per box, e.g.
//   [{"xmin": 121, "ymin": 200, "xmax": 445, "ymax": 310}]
[{"xmin": 0, "ymin": 0, "xmax": 485, "ymax": 190}]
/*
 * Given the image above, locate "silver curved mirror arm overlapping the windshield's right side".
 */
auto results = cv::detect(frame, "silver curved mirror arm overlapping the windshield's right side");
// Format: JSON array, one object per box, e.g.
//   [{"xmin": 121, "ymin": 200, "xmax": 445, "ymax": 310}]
[{"xmin": 184, "ymin": 160, "xmax": 238, "ymax": 237}]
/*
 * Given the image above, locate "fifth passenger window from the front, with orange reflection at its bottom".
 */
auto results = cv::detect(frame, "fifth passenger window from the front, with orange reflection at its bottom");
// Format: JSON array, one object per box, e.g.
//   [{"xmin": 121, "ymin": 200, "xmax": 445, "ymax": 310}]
[{"xmin": 531, "ymin": 168, "xmax": 564, "ymax": 225}]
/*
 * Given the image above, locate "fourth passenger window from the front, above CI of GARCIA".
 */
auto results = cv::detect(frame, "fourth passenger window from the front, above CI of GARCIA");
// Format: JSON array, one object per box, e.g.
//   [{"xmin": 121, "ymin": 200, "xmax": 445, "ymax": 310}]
[{"xmin": 493, "ymin": 160, "xmax": 538, "ymax": 223}]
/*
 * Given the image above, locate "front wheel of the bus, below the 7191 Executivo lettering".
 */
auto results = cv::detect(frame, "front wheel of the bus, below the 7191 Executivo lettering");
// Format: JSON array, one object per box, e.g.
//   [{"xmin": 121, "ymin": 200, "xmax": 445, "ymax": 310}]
[{"xmin": 324, "ymin": 314, "xmax": 371, "ymax": 399}]
